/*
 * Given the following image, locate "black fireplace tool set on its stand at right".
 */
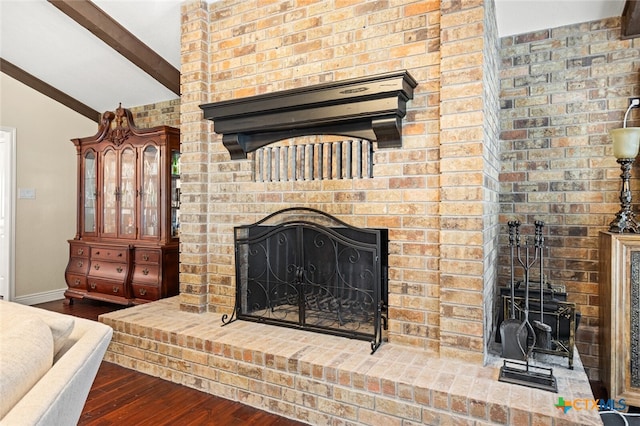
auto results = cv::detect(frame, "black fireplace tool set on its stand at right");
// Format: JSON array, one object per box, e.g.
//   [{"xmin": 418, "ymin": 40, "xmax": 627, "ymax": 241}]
[{"xmin": 499, "ymin": 221, "xmax": 558, "ymax": 392}]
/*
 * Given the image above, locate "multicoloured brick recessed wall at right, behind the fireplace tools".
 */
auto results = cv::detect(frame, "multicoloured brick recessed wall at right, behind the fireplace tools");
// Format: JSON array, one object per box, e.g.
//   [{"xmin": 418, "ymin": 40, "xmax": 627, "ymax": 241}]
[{"xmin": 500, "ymin": 18, "xmax": 640, "ymax": 380}]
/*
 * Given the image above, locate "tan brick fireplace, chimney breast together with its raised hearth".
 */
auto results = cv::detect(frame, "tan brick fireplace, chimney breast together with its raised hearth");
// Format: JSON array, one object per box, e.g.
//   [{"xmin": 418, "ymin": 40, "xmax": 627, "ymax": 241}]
[{"xmin": 104, "ymin": 0, "xmax": 640, "ymax": 424}]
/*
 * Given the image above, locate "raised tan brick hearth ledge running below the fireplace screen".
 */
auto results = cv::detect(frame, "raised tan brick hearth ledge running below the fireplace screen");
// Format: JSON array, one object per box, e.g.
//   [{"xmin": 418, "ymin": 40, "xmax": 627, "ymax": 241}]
[{"xmin": 100, "ymin": 297, "xmax": 601, "ymax": 425}]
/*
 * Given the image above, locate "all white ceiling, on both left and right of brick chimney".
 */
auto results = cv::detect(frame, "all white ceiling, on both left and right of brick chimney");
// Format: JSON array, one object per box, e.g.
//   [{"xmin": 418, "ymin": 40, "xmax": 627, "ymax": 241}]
[{"xmin": 0, "ymin": 0, "xmax": 625, "ymax": 116}]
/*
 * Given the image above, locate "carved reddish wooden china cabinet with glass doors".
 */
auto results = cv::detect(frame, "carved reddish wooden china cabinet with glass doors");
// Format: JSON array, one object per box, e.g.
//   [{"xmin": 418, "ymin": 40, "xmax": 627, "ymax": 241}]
[{"xmin": 65, "ymin": 106, "xmax": 180, "ymax": 305}]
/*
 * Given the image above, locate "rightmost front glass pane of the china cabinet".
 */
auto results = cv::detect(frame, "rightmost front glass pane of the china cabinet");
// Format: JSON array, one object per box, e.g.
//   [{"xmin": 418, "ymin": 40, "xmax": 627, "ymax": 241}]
[{"xmin": 140, "ymin": 146, "xmax": 160, "ymax": 237}]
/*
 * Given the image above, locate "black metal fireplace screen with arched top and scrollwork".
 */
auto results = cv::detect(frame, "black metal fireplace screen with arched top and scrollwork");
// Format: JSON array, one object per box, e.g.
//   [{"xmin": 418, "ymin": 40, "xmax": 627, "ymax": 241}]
[{"xmin": 223, "ymin": 208, "xmax": 388, "ymax": 353}]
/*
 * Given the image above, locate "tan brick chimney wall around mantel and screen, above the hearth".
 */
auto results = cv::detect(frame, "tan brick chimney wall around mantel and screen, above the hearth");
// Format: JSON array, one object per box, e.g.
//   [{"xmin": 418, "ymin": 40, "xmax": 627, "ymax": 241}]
[{"xmin": 180, "ymin": 0, "xmax": 499, "ymax": 362}]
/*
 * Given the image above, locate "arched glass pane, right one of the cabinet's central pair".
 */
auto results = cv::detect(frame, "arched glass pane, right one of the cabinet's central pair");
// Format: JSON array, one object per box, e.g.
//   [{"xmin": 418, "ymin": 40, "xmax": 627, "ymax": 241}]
[{"xmin": 119, "ymin": 148, "xmax": 136, "ymax": 238}]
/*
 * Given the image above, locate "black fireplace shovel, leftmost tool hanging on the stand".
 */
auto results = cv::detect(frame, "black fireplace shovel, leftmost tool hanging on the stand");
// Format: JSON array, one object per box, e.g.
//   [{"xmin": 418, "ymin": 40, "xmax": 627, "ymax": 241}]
[{"xmin": 500, "ymin": 221, "xmax": 527, "ymax": 360}]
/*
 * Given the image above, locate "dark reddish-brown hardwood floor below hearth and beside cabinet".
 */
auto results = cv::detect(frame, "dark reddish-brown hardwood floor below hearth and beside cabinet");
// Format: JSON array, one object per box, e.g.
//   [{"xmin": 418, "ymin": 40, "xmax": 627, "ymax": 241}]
[{"xmin": 35, "ymin": 300, "xmax": 304, "ymax": 426}]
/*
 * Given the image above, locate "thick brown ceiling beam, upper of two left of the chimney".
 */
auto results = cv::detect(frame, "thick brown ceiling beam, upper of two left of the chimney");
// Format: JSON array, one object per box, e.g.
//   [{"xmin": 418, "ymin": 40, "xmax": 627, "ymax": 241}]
[{"xmin": 48, "ymin": 0, "xmax": 180, "ymax": 96}]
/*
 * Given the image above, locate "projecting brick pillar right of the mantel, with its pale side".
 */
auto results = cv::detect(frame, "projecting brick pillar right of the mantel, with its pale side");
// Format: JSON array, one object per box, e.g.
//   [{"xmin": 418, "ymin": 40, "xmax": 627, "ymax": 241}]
[{"xmin": 436, "ymin": 1, "xmax": 499, "ymax": 361}]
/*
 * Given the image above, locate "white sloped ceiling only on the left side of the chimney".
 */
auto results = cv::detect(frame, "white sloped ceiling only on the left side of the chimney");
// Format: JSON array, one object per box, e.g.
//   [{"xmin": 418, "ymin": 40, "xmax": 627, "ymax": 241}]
[{"xmin": 0, "ymin": 0, "xmax": 180, "ymax": 112}]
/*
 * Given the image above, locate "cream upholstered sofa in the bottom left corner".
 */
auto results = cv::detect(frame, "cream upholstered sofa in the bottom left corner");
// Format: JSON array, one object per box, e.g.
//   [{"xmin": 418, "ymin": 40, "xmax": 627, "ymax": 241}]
[{"xmin": 0, "ymin": 300, "xmax": 113, "ymax": 426}]
